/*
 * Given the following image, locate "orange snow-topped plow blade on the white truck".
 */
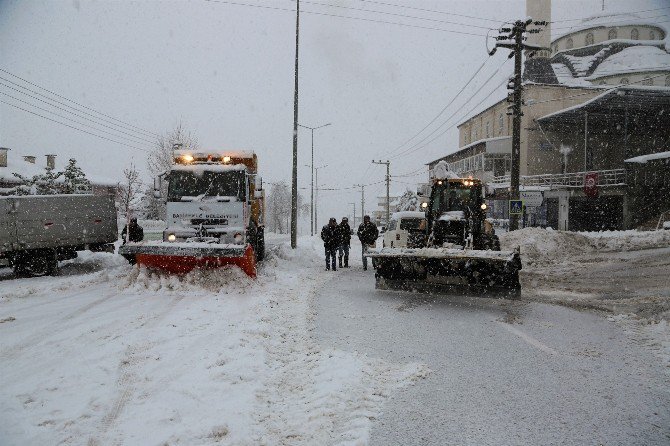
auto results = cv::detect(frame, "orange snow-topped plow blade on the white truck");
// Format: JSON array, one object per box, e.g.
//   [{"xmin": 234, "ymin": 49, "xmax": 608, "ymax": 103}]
[{"xmin": 119, "ymin": 242, "xmax": 256, "ymax": 278}]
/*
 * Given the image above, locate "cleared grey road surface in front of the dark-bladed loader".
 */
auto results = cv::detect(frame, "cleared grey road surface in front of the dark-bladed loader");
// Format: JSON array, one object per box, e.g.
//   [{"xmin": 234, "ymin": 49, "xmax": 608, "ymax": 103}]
[{"xmin": 316, "ymin": 270, "xmax": 670, "ymax": 446}]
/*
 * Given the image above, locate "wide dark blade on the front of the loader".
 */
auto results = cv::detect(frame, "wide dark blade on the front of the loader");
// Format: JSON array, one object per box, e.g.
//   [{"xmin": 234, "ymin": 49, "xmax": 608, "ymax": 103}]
[{"xmin": 366, "ymin": 248, "xmax": 521, "ymax": 294}]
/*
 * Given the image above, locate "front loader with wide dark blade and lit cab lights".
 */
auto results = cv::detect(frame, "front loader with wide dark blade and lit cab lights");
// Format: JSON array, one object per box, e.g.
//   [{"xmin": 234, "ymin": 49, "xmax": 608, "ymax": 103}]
[{"xmin": 366, "ymin": 162, "xmax": 521, "ymax": 296}]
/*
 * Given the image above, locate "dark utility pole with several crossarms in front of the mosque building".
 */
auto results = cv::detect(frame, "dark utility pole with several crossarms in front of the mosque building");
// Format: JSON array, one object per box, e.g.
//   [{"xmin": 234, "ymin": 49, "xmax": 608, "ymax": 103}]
[{"xmin": 489, "ymin": 19, "xmax": 547, "ymax": 231}]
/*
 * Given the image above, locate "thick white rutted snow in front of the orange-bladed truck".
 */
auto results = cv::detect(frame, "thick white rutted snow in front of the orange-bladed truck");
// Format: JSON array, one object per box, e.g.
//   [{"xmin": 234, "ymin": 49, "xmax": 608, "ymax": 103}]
[{"xmin": 0, "ymin": 242, "xmax": 427, "ymax": 446}]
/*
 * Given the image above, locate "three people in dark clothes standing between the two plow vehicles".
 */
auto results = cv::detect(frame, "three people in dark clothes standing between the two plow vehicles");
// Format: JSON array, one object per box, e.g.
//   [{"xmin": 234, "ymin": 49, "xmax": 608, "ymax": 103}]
[{"xmin": 321, "ymin": 215, "xmax": 379, "ymax": 271}]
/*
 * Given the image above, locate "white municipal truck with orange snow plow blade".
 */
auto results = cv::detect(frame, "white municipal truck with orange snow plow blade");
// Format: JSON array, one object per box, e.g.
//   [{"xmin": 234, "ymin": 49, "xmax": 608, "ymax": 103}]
[{"xmin": 119, "ymin": 150, "xmax": 265, "ymax": 277}]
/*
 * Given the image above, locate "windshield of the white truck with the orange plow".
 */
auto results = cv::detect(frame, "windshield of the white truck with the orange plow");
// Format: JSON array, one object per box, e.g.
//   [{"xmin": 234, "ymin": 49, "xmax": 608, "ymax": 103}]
[{"xmin": 168, "ymin": 170, "xmax": 245, "ymax": 201}]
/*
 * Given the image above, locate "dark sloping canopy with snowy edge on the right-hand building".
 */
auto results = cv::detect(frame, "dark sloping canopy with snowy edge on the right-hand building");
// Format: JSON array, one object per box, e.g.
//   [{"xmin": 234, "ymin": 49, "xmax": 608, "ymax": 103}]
[{"xmin": 537, "ymin": 86, "xmax": 670, "ymax": 124}]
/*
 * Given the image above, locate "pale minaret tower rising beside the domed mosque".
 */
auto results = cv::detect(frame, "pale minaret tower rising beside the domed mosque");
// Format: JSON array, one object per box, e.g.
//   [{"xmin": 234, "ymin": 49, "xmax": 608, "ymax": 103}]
[{"xmin": 523, "ymin": 0, "xmax": 558, "ymax": 84}]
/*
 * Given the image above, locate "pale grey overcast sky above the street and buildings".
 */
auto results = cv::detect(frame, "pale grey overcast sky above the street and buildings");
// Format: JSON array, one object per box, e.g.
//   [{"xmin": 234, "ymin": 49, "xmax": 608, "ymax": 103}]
[{"xmin": 0, "ymin": 0, "xmax": 670, "ymax": 228}]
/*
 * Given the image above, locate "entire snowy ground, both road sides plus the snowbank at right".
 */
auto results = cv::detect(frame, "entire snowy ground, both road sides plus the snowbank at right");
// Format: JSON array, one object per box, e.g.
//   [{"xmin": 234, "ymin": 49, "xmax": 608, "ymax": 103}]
[{"xmin": 0, "ymin": 230, "xmax": 670, "ymax": 446}]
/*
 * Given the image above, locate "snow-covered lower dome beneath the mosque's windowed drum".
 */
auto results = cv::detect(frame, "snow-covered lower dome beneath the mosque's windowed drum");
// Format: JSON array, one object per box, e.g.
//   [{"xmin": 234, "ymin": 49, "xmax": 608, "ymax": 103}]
[{"xmin": 588, "ymin": 46, "xmax": 670, "ymax": 79}]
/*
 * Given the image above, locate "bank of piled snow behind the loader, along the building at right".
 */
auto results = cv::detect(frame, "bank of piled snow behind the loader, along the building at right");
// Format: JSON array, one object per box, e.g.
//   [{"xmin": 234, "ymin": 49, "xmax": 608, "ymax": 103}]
[{"xmin": 500, "ymin": 228, "xmax": 670, "ymax": 266}]
